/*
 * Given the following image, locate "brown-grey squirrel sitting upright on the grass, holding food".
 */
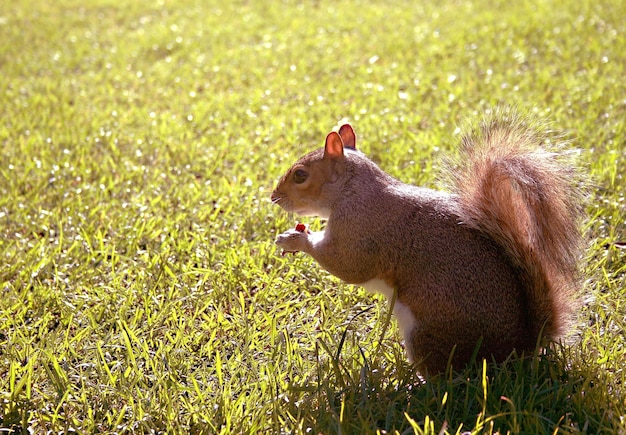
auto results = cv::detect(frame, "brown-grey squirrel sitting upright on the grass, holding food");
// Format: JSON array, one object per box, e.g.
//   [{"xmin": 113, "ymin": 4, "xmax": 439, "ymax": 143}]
[{"xmin": 271, "ymin": 110, "xmax": 584, "ymax": 374}]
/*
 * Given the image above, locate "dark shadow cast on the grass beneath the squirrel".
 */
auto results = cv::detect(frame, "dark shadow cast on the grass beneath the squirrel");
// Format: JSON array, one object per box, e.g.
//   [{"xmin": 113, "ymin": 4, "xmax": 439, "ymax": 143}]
[{"xmin": 288, "ymin": 349, "xmax": 621, "ymax": 434}]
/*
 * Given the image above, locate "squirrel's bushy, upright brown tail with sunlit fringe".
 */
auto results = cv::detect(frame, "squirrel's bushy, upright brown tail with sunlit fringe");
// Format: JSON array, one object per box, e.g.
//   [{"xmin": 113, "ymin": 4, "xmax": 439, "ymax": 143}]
[{"xmin": 454, "ymin": 109, "xmax": 584, "ymax": 339}]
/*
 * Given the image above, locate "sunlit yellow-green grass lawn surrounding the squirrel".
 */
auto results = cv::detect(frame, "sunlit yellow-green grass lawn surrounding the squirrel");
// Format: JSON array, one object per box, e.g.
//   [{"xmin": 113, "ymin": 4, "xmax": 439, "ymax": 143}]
[{"xmin": 0, "ymin": 0, "xmax": 626, "ymax": 434}]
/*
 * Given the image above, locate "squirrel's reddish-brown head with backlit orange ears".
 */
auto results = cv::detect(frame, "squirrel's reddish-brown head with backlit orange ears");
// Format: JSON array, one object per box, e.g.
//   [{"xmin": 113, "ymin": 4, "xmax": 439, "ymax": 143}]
[{"xmin": 271, "ymin": 124, "xmax": 356, "ymax": 218}]
